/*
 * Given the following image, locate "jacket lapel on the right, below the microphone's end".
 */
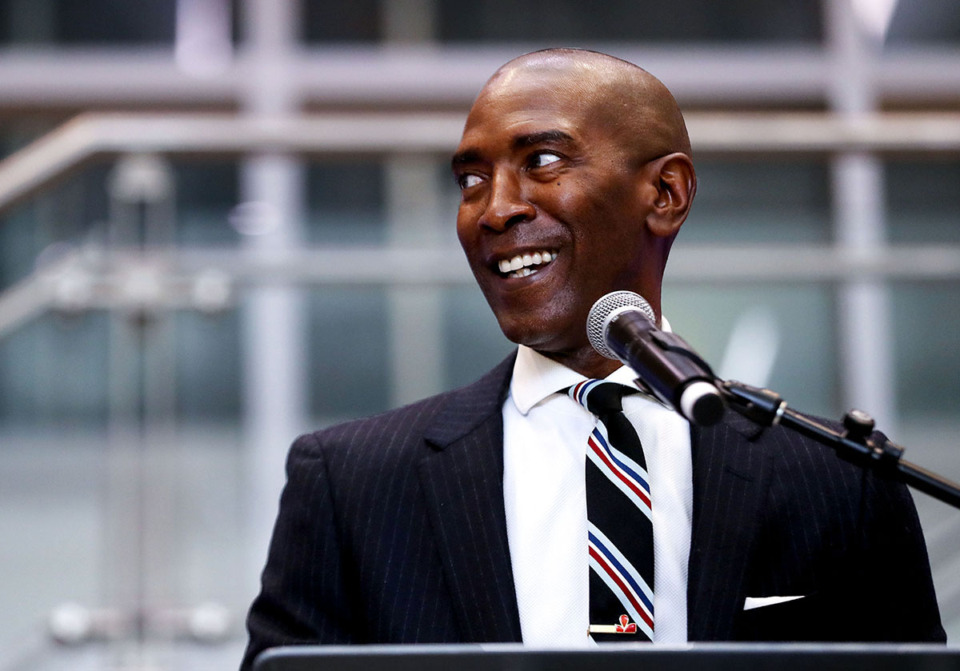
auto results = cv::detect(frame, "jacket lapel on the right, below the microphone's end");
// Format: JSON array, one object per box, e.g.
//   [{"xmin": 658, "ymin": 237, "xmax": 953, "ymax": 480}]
[{"xmin": 687, "ymin": 413, "xmax": 770, "ymax": 641}]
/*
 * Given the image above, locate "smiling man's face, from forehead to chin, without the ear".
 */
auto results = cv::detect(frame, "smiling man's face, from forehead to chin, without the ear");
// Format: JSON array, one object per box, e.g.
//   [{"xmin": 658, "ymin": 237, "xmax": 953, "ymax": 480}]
[{"xmin": 453, "ymin": 73, "xmax": 651, "ymax": 355}]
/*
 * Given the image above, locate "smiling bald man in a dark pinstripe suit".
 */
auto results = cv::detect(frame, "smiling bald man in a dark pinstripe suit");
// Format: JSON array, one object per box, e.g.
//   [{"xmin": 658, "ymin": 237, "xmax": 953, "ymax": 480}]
[{"xmin": 244, "ymin": 50, "xmax": 945, "ymax": 665}]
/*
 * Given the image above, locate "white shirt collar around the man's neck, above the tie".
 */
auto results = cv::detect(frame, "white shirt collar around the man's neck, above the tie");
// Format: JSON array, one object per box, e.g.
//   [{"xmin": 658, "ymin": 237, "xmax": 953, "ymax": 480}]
[{"xmin": 510, "ymin": 317, "xmax": 670, "ymax": 415}]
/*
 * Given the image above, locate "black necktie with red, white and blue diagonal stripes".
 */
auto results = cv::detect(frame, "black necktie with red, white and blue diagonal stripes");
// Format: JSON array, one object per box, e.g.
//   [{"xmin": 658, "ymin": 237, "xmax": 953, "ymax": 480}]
[{"xmin": 568, "ymin": 380, "xmax": 653, "ymax": 642}]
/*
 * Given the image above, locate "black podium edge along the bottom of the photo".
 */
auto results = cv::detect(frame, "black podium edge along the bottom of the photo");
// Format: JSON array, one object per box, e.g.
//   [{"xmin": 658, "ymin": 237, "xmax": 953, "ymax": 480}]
[{"xmin": 254, "ymin": 643, "xmax": 960, "ymax": 671}]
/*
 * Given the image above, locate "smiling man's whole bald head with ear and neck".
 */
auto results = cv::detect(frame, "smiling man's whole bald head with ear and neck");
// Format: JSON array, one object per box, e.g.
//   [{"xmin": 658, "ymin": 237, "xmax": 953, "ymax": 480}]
[{"xmin": 451, "ymin": 49, "xmax": 696, "ymax": 377}]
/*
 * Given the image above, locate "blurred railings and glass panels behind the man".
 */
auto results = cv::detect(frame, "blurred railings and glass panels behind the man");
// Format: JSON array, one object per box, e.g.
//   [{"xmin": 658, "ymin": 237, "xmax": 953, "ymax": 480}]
[{"xmin": 0, "ymin": 0, "xmax": 960, "ymax": 671}]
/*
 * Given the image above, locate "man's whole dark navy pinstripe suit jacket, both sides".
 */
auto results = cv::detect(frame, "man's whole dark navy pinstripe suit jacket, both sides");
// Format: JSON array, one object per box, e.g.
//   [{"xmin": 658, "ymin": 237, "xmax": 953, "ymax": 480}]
[{"xmin": 244, "ymin": 357, "xmax": 945, "ymax": 665}]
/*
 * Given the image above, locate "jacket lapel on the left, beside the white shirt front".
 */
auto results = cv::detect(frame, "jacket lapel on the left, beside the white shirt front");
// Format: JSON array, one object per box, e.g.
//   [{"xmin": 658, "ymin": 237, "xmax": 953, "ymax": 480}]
[{"xmin": 420, "ymin": 357, "xmax": 520, "ymax": 642}]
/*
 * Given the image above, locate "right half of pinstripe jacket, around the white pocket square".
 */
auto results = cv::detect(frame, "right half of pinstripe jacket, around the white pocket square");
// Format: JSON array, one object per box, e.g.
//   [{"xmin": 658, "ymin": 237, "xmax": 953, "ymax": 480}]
[{"xmin": 688, "ymin": 417, "xmax": 946, "ymax": 642}]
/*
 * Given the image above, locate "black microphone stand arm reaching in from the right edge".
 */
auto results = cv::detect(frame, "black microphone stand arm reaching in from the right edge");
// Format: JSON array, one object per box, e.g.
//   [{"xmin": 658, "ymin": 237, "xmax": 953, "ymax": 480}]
[{"xmin": 717, "ymin": 380, "xmax": 960, "ymax": 509}]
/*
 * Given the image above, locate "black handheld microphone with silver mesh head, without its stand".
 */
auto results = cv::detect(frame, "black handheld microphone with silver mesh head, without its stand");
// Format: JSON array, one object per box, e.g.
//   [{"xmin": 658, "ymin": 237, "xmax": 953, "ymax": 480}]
[{"xmin": 587, "ymin": 291, "xmax": 726, "ymax": 426}]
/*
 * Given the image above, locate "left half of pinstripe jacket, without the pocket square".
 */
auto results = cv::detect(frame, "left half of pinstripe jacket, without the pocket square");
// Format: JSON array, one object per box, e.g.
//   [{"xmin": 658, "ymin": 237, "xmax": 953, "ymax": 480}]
[{"xmin": 242, "ymin": 357, "xmax": 520, "ymax": 669}]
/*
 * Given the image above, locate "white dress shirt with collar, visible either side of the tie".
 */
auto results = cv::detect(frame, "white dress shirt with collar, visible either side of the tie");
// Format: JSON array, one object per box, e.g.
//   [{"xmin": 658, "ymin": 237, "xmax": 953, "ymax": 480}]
[{"xmin": 503, "ymin": 346, "xmax": 693, "ymax": 647}]
